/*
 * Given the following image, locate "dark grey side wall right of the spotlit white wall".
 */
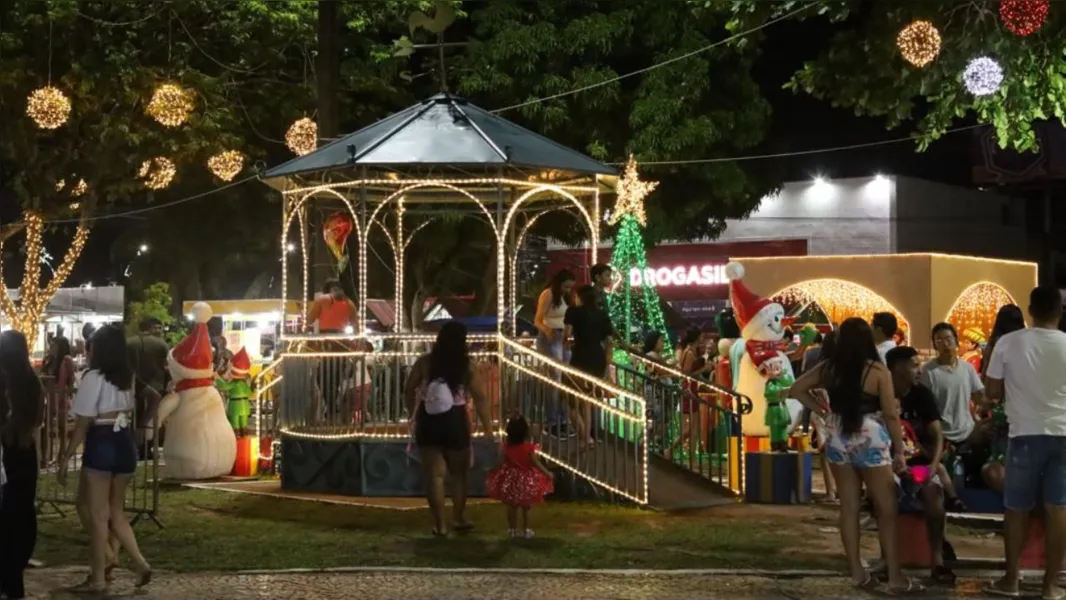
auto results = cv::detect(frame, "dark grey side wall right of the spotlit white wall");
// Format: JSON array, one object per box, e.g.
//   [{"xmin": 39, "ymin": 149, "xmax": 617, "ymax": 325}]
[{"xmin": 892, "ymin": 177, "xmax": 1031, "ymax": 259}]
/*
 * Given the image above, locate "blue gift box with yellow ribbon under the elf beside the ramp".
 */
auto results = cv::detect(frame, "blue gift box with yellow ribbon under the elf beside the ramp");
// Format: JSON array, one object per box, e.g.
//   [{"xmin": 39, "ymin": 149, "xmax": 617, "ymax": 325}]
[{"xmin": 744, "ymin": 452, "xmax": 813, "ymax": 504}]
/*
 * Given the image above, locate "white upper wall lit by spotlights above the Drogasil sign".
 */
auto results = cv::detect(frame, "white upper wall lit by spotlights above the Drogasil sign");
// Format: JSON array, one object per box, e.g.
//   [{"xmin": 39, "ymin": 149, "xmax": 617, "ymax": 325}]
[{"xmin": 718, "ymin": 177, "xmax": 895, "ymax": 255}]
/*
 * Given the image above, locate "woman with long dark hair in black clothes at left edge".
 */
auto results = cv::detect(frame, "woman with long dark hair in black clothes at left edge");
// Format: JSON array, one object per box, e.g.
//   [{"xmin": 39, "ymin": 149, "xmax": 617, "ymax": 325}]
[{"xmin": 0, "ymin": 330, "xmax": 44, "ymax": 598}]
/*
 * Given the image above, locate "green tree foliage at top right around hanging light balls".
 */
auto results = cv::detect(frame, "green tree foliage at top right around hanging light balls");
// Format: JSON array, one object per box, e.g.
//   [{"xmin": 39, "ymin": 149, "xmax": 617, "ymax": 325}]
[{"xmin": 730, "ymin": 0, "xmax": 1066, "ymax": 151}]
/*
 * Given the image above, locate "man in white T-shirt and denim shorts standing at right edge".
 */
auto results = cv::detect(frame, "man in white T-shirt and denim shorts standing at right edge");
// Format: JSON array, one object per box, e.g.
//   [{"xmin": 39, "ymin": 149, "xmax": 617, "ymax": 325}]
[{"xmin": 986, "ymin": 286, "xmax": 1066, "ymax": 598}]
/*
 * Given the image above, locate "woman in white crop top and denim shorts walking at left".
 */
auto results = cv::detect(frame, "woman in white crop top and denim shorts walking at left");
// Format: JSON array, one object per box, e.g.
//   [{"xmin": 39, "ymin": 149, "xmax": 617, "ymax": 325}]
[{"xmin": 56, "ymin": 325, "xmax": 151, "ymax": 593}]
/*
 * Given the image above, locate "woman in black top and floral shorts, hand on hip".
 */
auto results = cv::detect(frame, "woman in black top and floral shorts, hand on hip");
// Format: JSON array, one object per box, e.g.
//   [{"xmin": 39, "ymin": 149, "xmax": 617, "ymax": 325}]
[{"xmin": 790, "ymin": 318, "xmax": 920, "ymax": 594}]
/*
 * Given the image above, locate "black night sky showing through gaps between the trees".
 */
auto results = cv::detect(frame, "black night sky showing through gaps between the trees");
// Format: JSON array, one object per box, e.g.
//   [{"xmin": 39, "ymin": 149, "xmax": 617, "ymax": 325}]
[{"xmin": 35, "ymin": 12, "xmax": 989, "ymax": 286}]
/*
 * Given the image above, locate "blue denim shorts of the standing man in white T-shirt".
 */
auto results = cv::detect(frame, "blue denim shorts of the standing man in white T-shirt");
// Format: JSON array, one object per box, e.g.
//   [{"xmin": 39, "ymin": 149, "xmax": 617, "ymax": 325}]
[{"xmin": 1003, "ymin": 436, "xmax": 1066, "ymax": 512}]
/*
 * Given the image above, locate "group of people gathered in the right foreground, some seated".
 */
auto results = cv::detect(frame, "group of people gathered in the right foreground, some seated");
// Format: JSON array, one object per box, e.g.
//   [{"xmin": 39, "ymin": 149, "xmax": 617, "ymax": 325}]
[{"xmin": 791, "ymin": 287, "xmax": 1066, "ymax": 599}]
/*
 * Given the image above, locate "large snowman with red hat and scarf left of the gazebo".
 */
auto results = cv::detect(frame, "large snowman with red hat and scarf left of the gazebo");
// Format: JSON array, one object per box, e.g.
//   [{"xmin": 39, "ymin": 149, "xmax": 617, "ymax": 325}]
[{"xmin": 159, "ymin": 303, "xmax": 237, "ymax": 481}]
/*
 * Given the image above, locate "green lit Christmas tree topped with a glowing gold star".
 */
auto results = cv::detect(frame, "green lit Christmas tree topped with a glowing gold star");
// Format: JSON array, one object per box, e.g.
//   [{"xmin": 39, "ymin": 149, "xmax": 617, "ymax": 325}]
[{"xmin": 608, "ymin": 156, "xmax": 674, "ymax": 357}]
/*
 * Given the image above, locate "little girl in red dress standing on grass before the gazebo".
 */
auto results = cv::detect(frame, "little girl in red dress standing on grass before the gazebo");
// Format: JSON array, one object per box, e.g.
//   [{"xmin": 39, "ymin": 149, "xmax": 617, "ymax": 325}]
[{"xmin": 486, "ymin": 416, "xmax": 553, "ymax": 538}]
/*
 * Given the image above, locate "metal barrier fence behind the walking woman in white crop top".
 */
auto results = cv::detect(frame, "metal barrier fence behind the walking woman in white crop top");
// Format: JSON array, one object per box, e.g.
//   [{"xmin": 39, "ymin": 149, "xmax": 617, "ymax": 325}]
[{"xmin": 37, "ymin": 376, "xmax": 163, "ymax": 528}]
